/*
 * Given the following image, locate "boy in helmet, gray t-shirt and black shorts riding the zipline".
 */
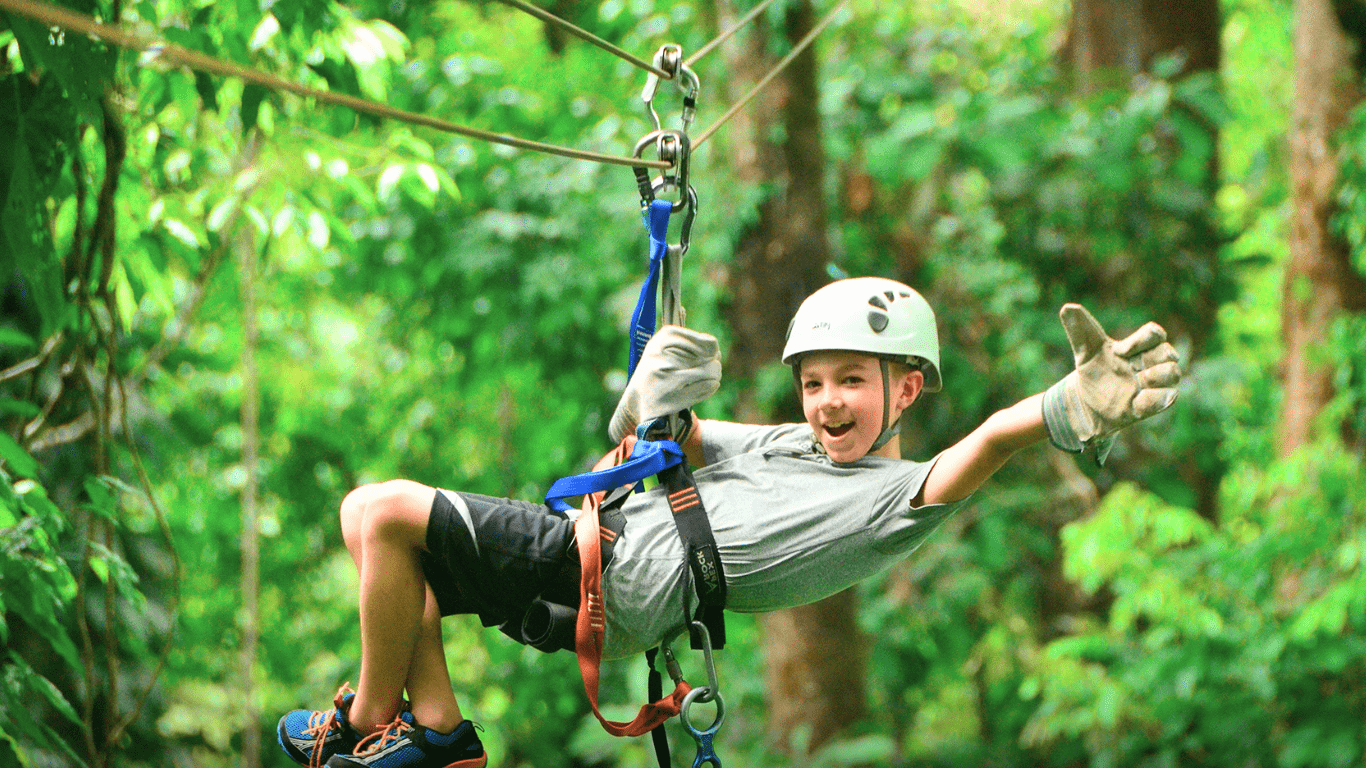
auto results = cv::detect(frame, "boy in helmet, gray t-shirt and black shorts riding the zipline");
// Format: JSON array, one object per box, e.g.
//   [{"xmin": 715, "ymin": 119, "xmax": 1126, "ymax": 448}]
[{"xmin": 279, "ymin": 277, "xmax": 1180, "ymax": 768}]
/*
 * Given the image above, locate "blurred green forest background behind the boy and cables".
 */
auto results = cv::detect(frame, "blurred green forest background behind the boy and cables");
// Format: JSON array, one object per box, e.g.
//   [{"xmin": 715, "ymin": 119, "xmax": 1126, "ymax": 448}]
[{"xmin": 0, "ymin": 0, "xmax": 1366, "ymax": 768}]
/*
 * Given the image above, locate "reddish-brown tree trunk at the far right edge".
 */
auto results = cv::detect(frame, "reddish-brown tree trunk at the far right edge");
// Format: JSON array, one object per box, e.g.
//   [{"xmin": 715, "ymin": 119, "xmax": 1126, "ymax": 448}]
[{"xmin": 1277, "ymin": 0, "xmax": 1366, "ymax": 455}]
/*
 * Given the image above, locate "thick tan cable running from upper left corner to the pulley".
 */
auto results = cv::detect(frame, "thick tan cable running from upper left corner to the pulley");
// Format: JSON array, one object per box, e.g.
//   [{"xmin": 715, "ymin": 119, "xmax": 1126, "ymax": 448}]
[{"xmin": 0, "ymin": 0, "xmax": 671, "ymax": 169}]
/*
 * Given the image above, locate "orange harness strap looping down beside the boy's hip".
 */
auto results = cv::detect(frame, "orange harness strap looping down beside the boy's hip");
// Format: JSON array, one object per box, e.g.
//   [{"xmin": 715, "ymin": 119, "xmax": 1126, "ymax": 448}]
[{"xmin": 574, "ymin": 435, "xmax": 693, "ymax": 737}]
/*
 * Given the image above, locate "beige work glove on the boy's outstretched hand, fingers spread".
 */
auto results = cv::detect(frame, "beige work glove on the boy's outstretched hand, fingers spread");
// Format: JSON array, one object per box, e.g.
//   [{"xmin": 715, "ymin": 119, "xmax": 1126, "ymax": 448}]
[{"xmin": 1044, "ymin": 303, "xmax": 1182, "ymax": 465}]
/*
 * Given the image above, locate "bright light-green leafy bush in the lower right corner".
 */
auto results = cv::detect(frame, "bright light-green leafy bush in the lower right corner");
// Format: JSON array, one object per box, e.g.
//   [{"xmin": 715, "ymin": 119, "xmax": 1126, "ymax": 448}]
[{"xmin": 1022, "ymin": 443, "xmax": 1366, "ymax": 765}]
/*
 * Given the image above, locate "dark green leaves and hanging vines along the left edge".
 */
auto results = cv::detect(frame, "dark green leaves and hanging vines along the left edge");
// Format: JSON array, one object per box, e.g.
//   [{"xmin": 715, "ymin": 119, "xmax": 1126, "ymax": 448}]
[{"xmin": 0, "ymin": 19, "xmax": 184, "ymax": 768}]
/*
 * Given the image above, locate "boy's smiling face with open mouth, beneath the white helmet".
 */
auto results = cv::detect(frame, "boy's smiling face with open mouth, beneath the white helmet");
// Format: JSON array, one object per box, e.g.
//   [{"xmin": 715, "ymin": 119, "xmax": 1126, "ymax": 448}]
[{"xmin": 799, "ymin": 351, "xmax": 925, "ymax": 462}]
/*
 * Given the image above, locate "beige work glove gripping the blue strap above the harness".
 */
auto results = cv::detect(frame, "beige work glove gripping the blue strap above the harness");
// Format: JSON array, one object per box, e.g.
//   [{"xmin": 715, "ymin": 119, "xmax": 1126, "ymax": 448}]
[{"xmin": 608, "ymin": 325, "xmax": 721, "ymax": 441}]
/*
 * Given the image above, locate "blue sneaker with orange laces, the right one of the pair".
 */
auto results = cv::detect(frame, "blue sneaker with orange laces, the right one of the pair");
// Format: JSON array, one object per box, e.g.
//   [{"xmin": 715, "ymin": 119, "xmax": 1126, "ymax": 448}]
[{"xmin": 326, "ymin": 715, "xmax": 489, "ymax": 768}]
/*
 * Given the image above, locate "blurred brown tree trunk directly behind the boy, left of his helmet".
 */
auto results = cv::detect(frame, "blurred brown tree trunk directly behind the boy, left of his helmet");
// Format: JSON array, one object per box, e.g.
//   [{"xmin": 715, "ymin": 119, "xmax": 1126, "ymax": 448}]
[{"xmin": 719, "ymin": 0, "xmax": 866, "ymax": 749}]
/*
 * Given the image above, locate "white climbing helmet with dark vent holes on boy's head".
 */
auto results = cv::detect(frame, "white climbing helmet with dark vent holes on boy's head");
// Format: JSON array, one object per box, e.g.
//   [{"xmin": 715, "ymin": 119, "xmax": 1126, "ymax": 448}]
[{"xmin": 783, "ymin": 277, "xmax": 944, "ymax": 392}]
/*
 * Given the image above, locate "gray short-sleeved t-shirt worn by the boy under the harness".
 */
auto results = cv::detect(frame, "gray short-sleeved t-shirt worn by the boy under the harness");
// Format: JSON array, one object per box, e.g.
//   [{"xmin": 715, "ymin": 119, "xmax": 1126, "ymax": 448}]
[{"xmin": 602, "ymin": 421, "xmax": 963, "ymax": 659}]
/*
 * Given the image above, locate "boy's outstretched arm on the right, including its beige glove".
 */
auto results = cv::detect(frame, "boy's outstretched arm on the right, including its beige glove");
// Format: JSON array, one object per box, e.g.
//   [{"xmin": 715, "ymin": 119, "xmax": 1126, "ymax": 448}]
[{"xmin": 915, "ymin": 303, "xmax": 1182, "ymax": 506}]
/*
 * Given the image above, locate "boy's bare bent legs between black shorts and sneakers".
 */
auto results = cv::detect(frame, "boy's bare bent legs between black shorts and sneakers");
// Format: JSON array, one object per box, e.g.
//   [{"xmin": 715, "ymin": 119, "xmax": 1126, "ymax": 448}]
[{"xmin": 342, "ymin": 480, "xmax": 462, "ymax": 732}]
